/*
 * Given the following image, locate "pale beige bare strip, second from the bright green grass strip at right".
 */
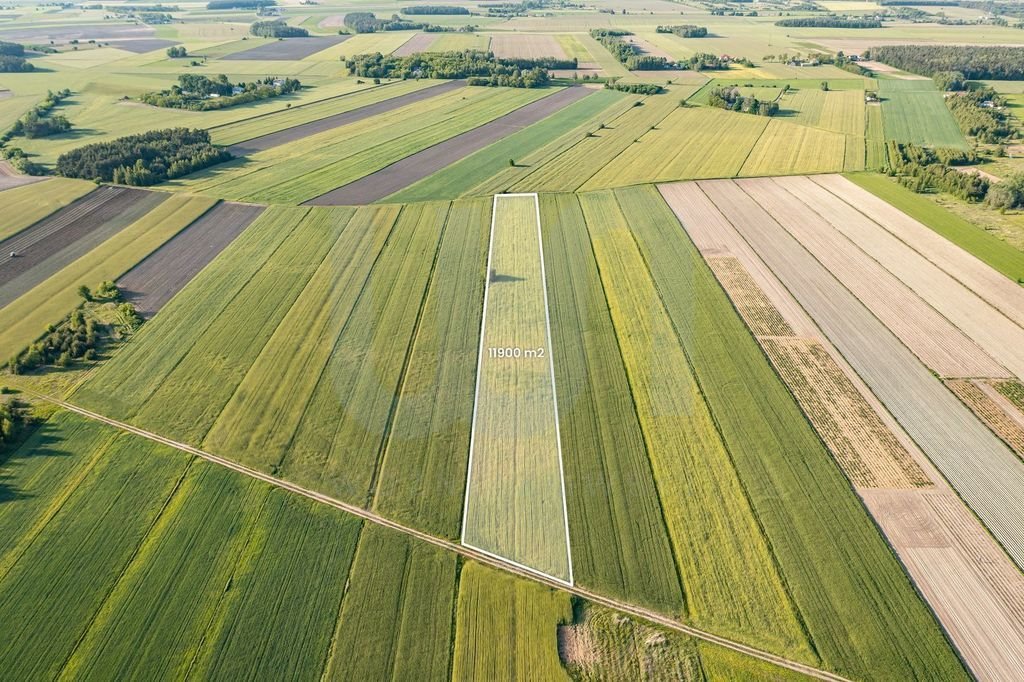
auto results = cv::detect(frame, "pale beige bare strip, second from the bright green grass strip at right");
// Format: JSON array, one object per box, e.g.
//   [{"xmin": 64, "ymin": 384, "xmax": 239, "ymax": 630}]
[{"xmin": 776, "ymin": 173, "xmax": 1024, "ymax": 377}]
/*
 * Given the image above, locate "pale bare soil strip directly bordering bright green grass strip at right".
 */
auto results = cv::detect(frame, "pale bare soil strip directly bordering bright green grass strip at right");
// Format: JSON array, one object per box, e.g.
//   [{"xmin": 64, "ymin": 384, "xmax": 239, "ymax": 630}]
[{"xmin": 811, "ymin": 175, "xmax": 1024, "ymax": 326}]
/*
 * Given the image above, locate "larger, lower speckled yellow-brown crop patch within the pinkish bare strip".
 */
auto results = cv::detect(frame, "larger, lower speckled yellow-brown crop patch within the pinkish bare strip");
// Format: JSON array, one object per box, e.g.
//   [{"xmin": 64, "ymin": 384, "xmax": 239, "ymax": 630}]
[{"xmin": 760, "ymin": 338, "xmax": 931, "ymax": 487}]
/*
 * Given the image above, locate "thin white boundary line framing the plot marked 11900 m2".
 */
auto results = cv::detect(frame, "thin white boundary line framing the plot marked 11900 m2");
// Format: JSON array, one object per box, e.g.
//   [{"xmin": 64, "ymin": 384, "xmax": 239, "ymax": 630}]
[{"xmin": 461, "ymin": 193, "xmax": 573, "ymax": 586}]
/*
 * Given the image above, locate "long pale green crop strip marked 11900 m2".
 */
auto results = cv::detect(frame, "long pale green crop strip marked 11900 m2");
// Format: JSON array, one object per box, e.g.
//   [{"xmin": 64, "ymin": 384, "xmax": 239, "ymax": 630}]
[{"xmin": 462, "ymin": 195, "xmax": 572, "ymax": 584}]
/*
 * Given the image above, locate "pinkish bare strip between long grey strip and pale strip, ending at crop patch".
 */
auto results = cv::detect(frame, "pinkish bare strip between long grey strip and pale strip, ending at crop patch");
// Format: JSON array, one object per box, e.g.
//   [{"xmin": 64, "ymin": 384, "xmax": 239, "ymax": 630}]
[{"xmin": 737, "ymin": 178, "xmax": 1007, "ymax": 377}]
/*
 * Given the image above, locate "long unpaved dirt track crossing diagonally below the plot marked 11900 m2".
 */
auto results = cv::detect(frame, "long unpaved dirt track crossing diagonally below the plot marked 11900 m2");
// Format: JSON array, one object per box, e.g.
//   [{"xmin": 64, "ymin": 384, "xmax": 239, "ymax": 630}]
[{"xmin": 32, "ymin": 390, "xmax": 846, "ymax": 682}]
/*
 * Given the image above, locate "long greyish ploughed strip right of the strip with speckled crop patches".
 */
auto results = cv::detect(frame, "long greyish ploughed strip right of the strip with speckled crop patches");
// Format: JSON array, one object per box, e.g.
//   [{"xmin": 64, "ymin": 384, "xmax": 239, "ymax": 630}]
[{"xmin": 696, "ymin": 175, "xmax": 1024, "ymax": 565}]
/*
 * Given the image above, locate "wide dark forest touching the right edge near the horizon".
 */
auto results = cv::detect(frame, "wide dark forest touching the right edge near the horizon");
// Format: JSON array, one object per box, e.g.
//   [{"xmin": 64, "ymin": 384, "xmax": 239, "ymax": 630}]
[{"xmin": 865, "ymin": 45, "xmax": 1024, "ymax": 81}]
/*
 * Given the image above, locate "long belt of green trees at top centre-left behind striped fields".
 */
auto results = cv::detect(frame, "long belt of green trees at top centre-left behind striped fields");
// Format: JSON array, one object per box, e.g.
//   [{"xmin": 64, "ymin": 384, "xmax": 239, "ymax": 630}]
[{"xmin": 345, "ymin": 50, "xmax": 577, "ymax": 87}]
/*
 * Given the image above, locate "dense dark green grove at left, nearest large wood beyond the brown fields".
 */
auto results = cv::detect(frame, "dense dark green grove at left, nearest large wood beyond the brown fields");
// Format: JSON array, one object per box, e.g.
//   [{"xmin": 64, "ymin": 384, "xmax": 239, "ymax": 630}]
[{"xmin": 56, "ymin": 128, "xmax": 231, "ymax": 185}]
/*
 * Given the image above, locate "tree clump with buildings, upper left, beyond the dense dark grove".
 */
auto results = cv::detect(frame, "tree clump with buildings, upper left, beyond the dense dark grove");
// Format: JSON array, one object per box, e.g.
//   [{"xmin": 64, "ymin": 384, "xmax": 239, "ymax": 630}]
[{"xmin": 139, "ymin": 74, "xmax": 302, "ymax": 112}]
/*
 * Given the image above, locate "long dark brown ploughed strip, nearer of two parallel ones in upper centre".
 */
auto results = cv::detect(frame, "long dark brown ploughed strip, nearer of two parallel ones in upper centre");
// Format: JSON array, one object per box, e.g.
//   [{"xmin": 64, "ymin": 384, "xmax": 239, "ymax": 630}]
[{"xmin": 304, "ymin": 87, "xmax": 594, "ymax": 206}]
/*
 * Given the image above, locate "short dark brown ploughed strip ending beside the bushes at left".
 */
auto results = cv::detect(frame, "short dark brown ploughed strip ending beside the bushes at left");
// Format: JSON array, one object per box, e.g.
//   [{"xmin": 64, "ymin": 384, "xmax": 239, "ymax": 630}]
[{"xmin": 118, "ymin": 202, "xmax": 265, "ymax": 317}]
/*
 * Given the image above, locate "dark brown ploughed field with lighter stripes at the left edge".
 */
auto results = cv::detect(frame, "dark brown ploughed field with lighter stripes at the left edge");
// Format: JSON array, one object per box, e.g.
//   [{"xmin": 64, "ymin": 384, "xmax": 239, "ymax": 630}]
[{"xmin": 0, "ymin": 187, "xmax": 170, "ymax": 306}]
